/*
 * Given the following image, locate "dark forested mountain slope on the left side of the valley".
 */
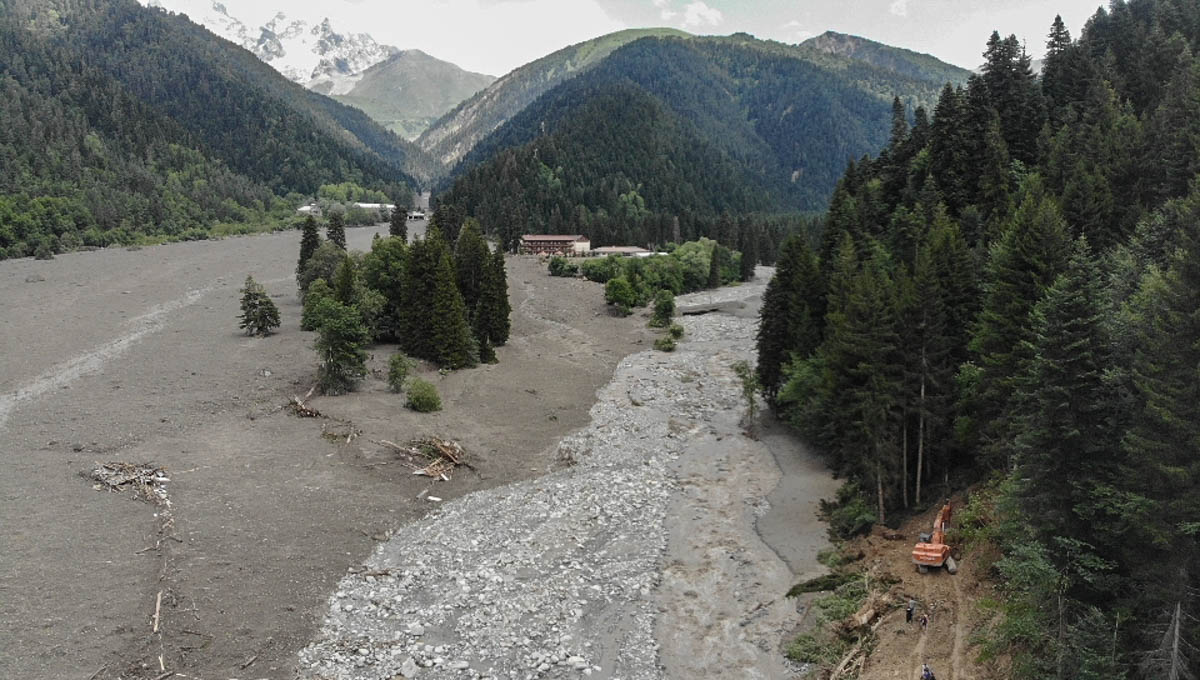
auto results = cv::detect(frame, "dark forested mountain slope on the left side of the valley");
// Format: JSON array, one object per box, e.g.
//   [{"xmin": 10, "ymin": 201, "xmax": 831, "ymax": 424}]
[{"xmin": 0, "ymin": 0, "xmax": 419, "ymax": 257}]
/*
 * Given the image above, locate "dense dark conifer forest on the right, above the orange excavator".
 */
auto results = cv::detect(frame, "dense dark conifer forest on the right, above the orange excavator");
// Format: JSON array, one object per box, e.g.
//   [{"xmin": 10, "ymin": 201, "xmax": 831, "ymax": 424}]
[{"xmin": 758, "ymin": 0, "xmax": 1200, "ymax": 680}]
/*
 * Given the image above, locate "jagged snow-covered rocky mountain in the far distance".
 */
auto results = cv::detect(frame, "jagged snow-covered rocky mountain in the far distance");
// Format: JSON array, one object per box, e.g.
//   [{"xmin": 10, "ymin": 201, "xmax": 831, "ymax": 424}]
[{"xmin": 142, "ymin": 0, "xmax": 398, "ymax": 83}]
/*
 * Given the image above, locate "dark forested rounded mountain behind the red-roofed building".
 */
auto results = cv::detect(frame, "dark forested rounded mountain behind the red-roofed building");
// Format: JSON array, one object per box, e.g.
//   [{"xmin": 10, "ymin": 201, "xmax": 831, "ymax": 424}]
[{"xmin": 439, "ymin": 34, "xmax": 964, "ymax": 250}]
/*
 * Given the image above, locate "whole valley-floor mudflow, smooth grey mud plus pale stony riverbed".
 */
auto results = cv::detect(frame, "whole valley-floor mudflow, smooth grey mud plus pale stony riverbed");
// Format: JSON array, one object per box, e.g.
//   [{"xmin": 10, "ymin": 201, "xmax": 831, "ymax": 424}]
[{"xmin": 0, "ymin": 224, "xmax": 834, "ymax": 680}]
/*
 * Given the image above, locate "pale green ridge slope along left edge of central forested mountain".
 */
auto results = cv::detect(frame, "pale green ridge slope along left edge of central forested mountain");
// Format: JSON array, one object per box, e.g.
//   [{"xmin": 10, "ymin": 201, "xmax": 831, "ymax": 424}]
[{"xmin": 416, "ymin": 29, "xmax": 689, "ymax": 168}]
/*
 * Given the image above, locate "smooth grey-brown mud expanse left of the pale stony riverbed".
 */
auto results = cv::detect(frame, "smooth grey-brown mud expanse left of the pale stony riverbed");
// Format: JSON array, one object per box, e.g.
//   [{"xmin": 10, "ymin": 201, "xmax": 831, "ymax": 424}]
[{"xmin": 0, "ymin": 229, "xmax": 649, "ymax": 680}]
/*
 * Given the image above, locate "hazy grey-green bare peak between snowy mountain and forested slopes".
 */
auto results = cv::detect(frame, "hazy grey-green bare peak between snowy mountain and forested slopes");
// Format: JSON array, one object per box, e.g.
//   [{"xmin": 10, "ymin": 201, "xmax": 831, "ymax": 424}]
[{"xmin": 321, "ymin": 49, "xmax": 496, "ymax": 139}]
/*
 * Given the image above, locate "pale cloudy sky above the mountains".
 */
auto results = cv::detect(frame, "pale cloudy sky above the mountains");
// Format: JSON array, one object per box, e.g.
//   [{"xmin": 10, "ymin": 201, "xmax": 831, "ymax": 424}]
[{"xmin": 204, "ymin": 0, "xmax": 1106, "ymax": 76}]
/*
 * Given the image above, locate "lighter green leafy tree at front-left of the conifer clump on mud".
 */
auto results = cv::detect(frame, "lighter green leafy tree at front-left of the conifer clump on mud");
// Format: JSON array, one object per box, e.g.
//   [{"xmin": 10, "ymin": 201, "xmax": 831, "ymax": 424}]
[{"xmin": 313, "ymin": 301, "xmax": 371, "ymax": 395}]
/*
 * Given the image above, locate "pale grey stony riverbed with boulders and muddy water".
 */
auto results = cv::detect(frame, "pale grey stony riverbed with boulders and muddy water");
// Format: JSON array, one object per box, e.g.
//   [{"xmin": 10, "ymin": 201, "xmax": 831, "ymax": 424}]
[{"xmin": 300, "ymin": 276, "xmax": 835, "ymax": 680}]
